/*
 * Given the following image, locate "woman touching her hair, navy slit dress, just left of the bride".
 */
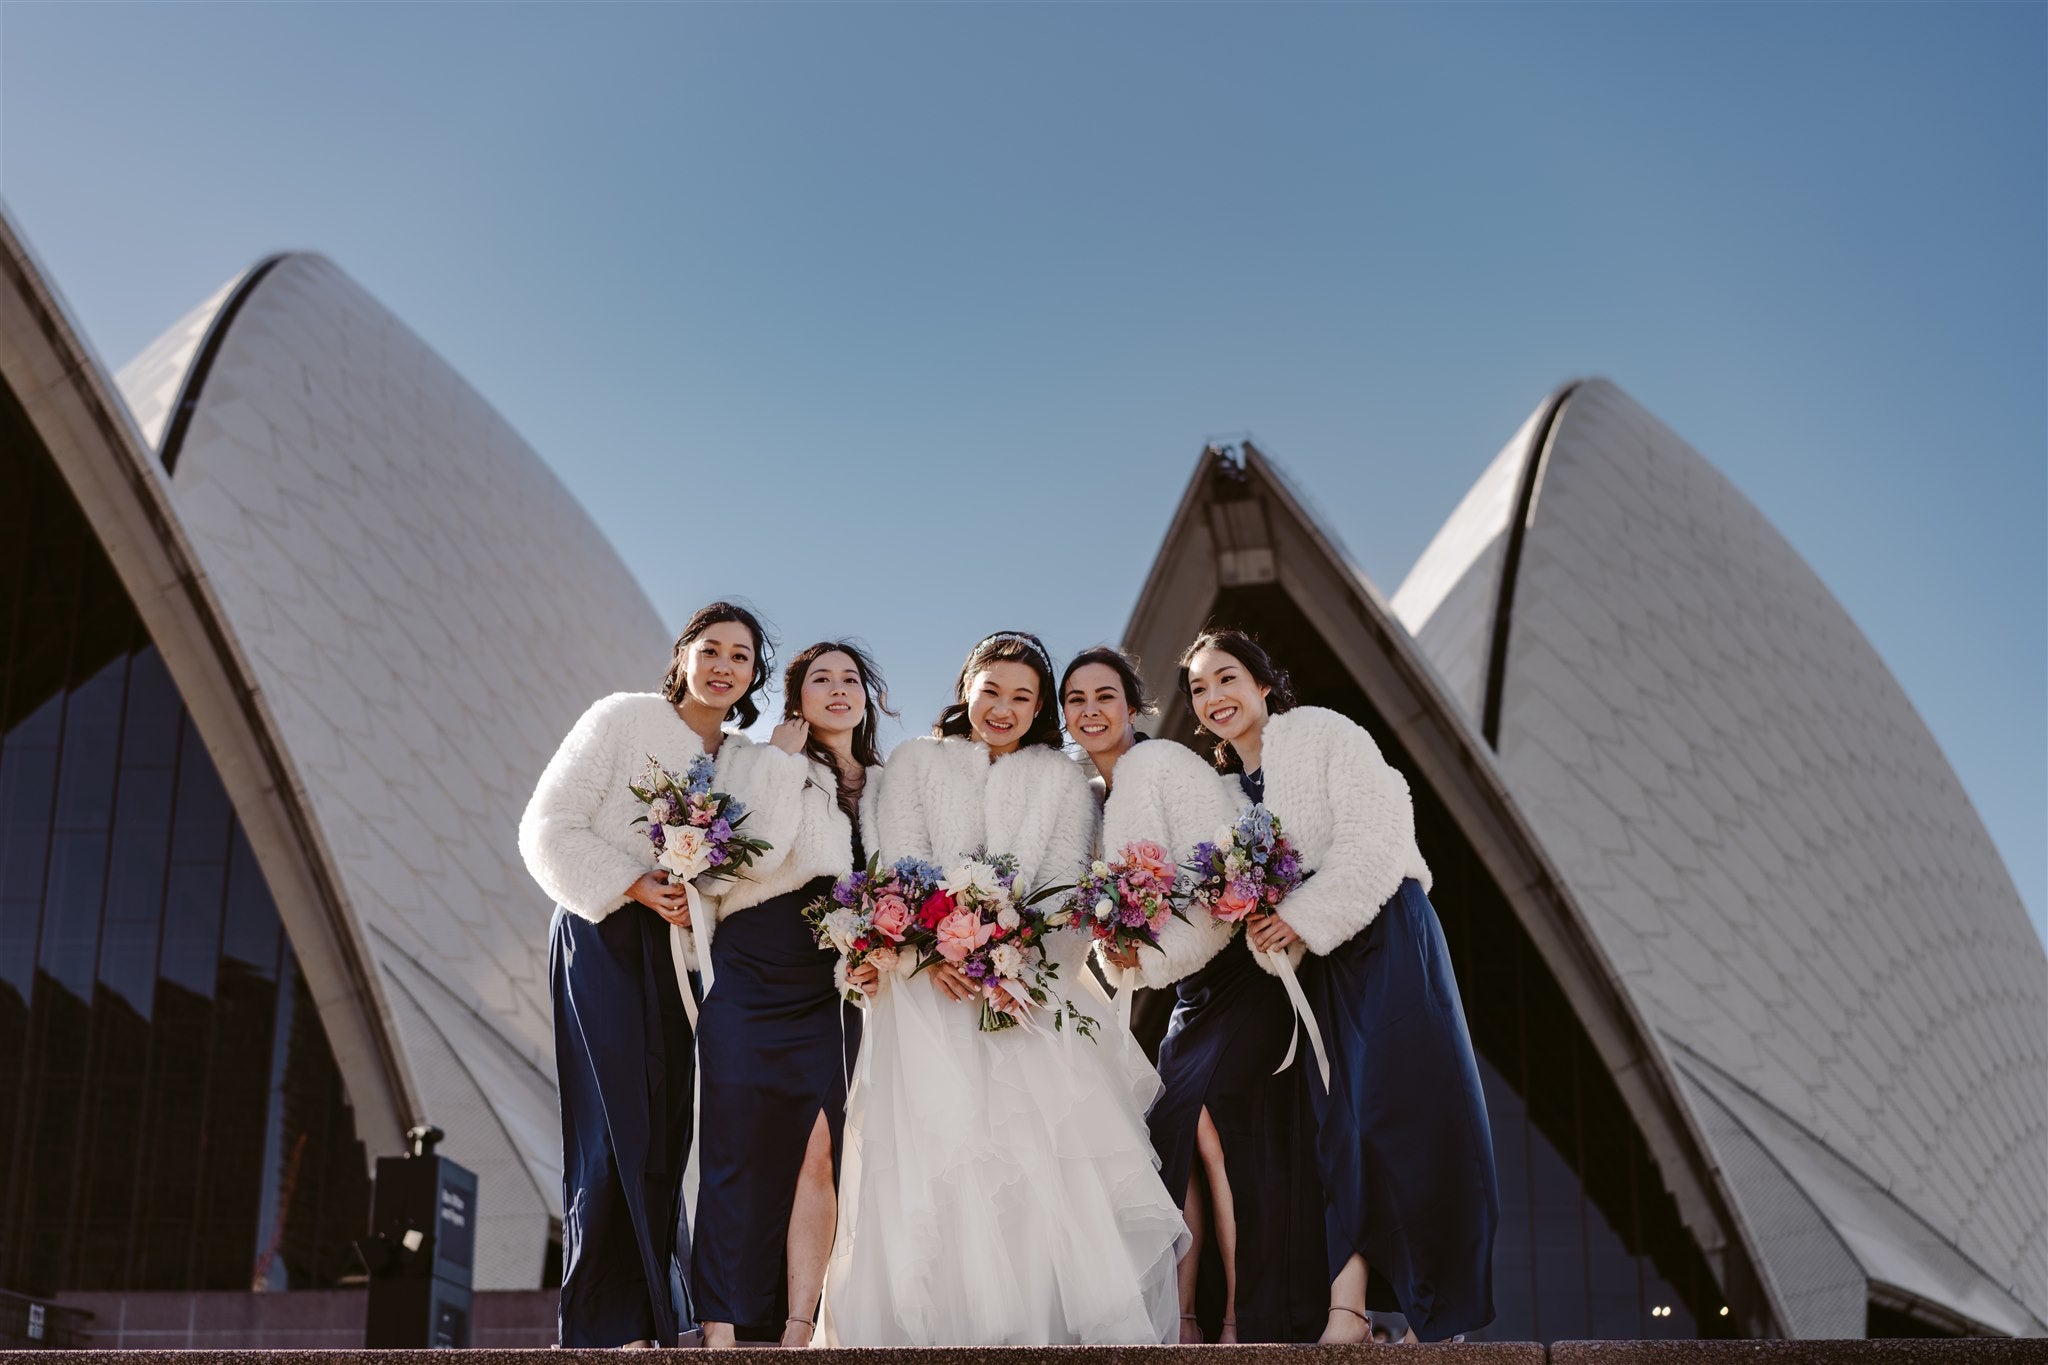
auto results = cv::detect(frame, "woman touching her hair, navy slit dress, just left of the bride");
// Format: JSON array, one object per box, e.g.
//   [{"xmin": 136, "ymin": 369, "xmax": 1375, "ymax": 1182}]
[{"xmin": 690, "ymin": 641, "xmax": 887, "ymax": 1347}]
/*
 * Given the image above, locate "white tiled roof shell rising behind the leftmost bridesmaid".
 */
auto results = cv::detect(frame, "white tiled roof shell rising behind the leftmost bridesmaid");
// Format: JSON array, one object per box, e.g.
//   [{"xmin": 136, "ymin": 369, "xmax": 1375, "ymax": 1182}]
[{"xmin": 119, "ymin": 256, "xmax": 668, "ymax": 1287}]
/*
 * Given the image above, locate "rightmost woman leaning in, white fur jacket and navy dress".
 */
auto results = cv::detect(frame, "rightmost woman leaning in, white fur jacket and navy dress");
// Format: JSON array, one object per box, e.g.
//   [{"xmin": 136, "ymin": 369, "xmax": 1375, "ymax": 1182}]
[{"xmin": 1180, "ymin": 630, "xmax": 1499, "ymax": 1342}]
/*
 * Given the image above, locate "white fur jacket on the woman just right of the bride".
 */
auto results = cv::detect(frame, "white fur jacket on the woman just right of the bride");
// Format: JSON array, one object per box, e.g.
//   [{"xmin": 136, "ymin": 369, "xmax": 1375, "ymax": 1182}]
[{"xmin": 1096, "ymin": 741, "xmax": 1249, "ymax": 990}]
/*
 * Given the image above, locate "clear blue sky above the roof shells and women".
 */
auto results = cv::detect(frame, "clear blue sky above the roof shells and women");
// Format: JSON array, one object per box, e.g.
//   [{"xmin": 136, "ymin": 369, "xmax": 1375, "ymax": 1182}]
[{"xmin": 0, "ymin": 4, "xmax": 2048, "ymax": 941}]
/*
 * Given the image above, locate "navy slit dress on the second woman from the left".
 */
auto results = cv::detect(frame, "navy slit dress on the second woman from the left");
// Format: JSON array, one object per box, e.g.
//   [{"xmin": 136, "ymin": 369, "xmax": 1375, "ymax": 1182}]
[{"xmin": 690, "ymin": 831, "xmax": 866, "ymax": 1336}]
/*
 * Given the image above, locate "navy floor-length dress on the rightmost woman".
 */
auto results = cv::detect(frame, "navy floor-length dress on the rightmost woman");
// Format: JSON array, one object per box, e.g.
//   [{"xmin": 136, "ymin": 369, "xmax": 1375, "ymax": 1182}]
[{"xmin": 1280, "ymin": 878, "xmax": 1501, "ymax": 1340}]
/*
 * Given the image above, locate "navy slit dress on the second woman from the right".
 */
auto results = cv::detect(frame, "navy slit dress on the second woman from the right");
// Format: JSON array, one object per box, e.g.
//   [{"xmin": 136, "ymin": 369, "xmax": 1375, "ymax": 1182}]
[{"xmin": 1147, "ymin": 773, "xmax": 1329, "ymax": 1342}]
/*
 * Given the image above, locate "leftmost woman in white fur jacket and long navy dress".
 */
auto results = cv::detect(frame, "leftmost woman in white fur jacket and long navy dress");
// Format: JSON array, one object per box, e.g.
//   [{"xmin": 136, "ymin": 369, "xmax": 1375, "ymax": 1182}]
[{"xmin": 518, "ymin": 602, "xmax": 768, "ymax": 1347}]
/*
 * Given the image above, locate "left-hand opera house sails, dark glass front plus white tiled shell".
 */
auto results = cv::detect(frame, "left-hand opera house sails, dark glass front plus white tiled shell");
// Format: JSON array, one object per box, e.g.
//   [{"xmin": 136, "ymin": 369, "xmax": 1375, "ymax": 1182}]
[{"xmin": 0, "ymin": 210, "xmax": 668, "ymax": 1289}]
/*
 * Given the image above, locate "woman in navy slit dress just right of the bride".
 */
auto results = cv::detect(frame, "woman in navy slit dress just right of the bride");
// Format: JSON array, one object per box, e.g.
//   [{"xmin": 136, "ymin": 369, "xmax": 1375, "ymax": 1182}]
[{"xmin": 1097, "ymin": 651, "xmax": 1329, "ymax": 1342}]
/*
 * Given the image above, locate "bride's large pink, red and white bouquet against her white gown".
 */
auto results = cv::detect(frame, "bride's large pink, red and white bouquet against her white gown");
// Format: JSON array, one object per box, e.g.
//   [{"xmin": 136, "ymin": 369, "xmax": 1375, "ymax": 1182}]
[{"xmin": 918, "ymin": 849, "xmax": 1096, "ymax": 1038}]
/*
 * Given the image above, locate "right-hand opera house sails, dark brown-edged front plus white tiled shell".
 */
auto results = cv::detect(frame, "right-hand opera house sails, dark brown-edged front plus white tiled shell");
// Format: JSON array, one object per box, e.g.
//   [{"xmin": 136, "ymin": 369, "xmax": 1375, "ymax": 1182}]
[{"xmin": 1126, "ymin": 381, "xmax": 2048, "ymax": 1340}]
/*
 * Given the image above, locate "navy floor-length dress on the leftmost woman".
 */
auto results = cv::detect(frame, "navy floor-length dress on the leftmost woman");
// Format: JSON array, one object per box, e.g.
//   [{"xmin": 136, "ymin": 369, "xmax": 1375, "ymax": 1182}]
[{"xmin": 547, "ymin": 902, "xmax": 690, "ymax": 1347}]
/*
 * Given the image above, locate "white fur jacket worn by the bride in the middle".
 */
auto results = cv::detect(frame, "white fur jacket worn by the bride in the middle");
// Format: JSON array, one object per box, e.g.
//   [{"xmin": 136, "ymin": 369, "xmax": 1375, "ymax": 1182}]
[{"xmin": 877, "ymin": 737, "xmax": 1096, "ymax": 886}]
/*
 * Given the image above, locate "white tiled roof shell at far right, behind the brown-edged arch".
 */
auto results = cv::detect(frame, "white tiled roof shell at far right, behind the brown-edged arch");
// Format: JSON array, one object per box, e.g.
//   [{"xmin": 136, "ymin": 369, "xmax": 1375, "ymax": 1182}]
[{"xmin": 1393, "ymin": 381, "xmax": 2048, "ymax": 1334}]
